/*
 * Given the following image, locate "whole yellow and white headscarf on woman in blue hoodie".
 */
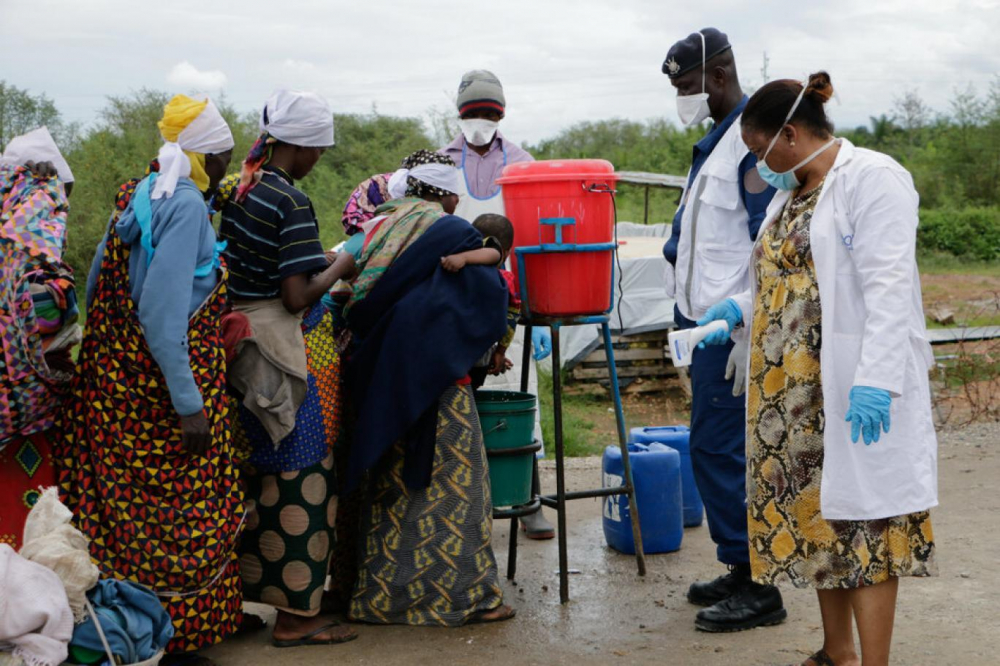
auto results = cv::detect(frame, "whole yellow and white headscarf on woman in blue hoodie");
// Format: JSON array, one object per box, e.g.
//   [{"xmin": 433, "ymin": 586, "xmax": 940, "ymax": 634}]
[{"xmin": 150, "ymin": 95, "xmax": 236, "ymax": 199}]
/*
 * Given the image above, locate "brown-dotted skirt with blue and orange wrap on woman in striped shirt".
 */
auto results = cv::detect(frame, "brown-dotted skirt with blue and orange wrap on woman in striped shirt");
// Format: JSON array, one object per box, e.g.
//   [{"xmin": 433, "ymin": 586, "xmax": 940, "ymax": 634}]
[{"xmin": 234, "ymin": 305, "xmax": 342, "ymax": 616}]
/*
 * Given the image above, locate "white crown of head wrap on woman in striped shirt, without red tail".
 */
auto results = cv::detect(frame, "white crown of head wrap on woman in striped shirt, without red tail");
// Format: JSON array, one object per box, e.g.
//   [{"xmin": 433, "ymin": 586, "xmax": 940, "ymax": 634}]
[{"xmin": 260, "ymin": 90, "xmax": 333, "ymax": 148}]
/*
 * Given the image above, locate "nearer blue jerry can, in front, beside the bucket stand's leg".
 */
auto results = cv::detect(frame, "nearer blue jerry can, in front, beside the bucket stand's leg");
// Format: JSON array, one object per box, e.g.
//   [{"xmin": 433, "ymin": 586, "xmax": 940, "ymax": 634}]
[{"xmin": 602, "ymin": 444, "xmax": 684, "ymax": 555}]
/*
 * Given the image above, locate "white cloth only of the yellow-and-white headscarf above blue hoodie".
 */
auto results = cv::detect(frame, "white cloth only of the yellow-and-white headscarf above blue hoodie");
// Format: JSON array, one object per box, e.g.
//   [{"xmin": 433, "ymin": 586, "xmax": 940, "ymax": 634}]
[{"xmin": 150, "ymin": 96, "xmax": 236, "ymax": 199}]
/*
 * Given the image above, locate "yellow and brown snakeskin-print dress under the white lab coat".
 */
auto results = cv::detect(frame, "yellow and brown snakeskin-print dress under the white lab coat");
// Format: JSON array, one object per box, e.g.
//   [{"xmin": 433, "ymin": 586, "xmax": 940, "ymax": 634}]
[{"xmin": 747, "ymin": 188, "xmax": 936, "ymax": 589}]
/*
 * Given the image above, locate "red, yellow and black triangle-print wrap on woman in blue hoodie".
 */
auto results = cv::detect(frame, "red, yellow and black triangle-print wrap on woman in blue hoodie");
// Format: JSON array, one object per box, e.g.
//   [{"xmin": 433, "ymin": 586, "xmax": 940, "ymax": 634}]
[{"xmin": 55, "ymin": 227, "xmax": 243, "ymax": 652}]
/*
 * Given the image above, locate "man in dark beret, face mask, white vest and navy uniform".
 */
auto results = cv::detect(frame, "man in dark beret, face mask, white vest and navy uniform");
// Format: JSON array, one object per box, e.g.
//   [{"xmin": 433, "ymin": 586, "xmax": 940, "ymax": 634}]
[{"xmin": 662, "ymin": 28, "xmax": 786, "ymax": 631}]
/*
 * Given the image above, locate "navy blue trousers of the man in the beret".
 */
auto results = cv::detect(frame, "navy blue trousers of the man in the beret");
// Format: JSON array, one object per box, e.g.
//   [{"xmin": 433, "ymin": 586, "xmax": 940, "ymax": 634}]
[{"xmin": 674, "ymin": 307, "xmax": 750, "ymax": 564}]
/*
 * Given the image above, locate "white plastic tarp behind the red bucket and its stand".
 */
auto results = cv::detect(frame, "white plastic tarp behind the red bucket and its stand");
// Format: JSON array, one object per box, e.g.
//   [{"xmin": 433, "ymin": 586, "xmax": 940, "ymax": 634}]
[{"xmin": 560, "ymin": 222, "xmax": 674, "ymax": 368}]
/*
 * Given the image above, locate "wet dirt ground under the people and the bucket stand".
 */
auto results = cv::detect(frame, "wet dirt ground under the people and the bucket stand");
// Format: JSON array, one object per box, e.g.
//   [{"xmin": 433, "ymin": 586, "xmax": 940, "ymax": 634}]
[{"xmin": 206, "ymin": 423, "xmax": 1000, "ymax": 666}]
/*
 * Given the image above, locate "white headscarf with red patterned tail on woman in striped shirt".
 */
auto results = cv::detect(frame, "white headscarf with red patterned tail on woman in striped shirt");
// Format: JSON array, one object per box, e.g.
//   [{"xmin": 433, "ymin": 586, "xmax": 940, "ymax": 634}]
[{"xmin": 236, "ymin": 90, "xmax": 334, "ymax": 201}]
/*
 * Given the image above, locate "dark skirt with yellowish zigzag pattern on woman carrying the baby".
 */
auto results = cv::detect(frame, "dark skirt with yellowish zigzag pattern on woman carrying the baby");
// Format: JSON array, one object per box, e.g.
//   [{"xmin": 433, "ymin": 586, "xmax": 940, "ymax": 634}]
[{"xmin": 349, "ymin": 386, "xmax": 503, "ymax": 627}]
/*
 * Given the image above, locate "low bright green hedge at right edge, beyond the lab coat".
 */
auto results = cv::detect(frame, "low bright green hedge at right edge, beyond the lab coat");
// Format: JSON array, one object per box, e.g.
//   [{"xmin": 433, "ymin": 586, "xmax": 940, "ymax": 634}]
[{"xmin": 917, "ymin": 206, "xmax": 1000, "ymax": 261}]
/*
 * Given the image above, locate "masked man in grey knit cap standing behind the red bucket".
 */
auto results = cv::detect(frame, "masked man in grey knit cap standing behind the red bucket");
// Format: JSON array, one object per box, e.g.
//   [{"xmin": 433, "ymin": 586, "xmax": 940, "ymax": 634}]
[{"xmin": 438, "ymin": 69, "xmax": 555, "ymax": 539}]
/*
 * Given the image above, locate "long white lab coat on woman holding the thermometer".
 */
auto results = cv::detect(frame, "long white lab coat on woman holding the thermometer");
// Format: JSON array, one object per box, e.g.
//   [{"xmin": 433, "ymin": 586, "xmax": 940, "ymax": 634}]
[{"xmin": 735, "ymin": 139, "xmax": 938, "ymax": 520}]
